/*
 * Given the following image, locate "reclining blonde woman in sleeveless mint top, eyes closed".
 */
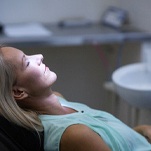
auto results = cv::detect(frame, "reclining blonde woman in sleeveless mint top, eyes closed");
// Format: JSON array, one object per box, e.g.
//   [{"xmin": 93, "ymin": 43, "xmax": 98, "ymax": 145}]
[{"xmin": 0, "ymin": 47, "xmax": 151, "ymax": 151}]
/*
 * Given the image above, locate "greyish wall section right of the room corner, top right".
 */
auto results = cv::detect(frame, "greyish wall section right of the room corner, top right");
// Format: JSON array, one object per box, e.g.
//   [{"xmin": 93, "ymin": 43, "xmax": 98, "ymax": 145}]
[{"xmin": 119, "ymin": 0, "xmax": 151, "ymax": 31}]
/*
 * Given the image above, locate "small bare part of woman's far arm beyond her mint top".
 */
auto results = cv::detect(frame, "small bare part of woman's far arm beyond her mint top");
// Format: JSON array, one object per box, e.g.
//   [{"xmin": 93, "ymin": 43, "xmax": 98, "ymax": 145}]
[{"xmin": 134, "ymin": 125, "xmax": 151, "ymax": 143}]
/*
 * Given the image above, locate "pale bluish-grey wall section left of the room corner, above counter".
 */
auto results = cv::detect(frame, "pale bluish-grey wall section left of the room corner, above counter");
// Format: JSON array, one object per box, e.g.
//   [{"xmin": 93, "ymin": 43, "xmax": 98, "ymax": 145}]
[{"xmin": 0, "ymin": 0, "xmax": 118, "ymax": 23}]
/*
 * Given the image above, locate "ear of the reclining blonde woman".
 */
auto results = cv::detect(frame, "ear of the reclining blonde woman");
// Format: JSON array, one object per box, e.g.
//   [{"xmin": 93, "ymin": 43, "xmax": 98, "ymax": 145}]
[{"xmin": 13, "ymin": 86, "xmax": 28, "ymax": 100}]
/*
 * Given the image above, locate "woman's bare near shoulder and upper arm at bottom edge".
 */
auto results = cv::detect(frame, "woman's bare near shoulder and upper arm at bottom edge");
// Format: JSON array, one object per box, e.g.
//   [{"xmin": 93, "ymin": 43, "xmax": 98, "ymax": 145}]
[{"xmin": 60, "ymin": 124, "xmax": 111, "ymax": 151}]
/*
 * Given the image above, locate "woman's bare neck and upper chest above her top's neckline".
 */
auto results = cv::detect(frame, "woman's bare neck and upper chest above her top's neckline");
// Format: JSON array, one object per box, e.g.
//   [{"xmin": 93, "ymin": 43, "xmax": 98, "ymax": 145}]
[{"xmin": 20, "ymin": 93, "xmax": 75, "ymax": 115}]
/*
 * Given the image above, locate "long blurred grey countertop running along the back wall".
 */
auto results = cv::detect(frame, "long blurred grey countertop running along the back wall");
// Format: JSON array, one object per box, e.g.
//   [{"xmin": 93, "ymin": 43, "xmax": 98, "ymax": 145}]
[{"xmin": 0, "ymin": 24, "xmax": 151, "ymax": 46}]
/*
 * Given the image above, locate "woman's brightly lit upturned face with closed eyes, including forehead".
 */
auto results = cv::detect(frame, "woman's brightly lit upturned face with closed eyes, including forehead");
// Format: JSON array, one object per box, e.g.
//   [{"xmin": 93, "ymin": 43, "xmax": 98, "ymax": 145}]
[{"xmin": 2, "ymin": 47, "xmax": 57, "ymax": 95}]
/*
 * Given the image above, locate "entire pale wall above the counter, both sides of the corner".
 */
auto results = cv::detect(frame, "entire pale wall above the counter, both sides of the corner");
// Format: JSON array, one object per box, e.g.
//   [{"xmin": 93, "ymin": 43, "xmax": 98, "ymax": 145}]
[{"xmin": 0, "ymin": 0, "xmax": 151, "ymax": 31}]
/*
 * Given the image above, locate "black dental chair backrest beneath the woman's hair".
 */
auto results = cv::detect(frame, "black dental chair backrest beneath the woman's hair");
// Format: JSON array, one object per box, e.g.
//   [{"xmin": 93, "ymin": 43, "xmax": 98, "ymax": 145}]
[{"xmin": 0, "ymin": 116, "xmax": 44, "ymax": 151}]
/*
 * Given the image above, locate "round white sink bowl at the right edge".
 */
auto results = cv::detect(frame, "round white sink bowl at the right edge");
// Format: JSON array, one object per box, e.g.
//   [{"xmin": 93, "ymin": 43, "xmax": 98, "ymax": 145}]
[{"xmin": 112, "ymin": 63, "xmax": 151, "ymax": 109}]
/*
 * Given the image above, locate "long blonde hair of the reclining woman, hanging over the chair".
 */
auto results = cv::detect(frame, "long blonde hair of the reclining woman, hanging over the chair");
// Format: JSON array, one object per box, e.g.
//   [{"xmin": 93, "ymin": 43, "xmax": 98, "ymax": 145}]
[{"xmin": 0, "ymin": 47, "xmax": 43, "ymax": 131}]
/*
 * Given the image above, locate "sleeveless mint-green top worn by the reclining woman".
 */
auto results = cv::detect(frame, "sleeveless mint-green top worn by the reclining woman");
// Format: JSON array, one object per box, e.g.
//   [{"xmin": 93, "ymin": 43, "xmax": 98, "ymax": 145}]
[{"xmin": 39, "ymin": 97, "xmax": 151, "ymax": 151}]
